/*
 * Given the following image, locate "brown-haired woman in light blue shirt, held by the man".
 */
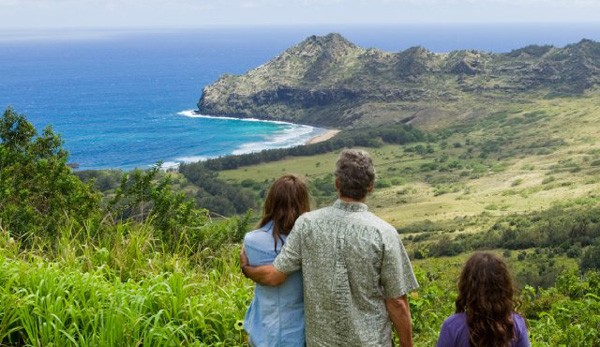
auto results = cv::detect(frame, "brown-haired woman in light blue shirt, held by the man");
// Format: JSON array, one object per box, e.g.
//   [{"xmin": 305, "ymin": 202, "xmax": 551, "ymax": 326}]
[{"xmin": 244, "ymin": 175, "xmax": 310, "ymax": 347}]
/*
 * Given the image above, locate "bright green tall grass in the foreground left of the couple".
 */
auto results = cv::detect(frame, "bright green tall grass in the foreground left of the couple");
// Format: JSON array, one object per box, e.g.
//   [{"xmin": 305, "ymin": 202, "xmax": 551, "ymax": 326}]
[{"xmin": 0, "ymin": 243, "xmax": 251, "ymax": 346}]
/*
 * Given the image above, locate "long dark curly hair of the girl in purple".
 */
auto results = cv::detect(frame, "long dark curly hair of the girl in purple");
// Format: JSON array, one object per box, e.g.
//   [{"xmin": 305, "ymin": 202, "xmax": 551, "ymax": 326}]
[{"xmin": 455, "ymin": 252, "xmax": 515, "ymax": 347}]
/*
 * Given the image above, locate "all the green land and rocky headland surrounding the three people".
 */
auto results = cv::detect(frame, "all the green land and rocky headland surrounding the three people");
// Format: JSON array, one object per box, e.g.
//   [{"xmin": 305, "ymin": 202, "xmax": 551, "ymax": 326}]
[{"xmin": 0, "ymin": 30, "xmax": 600, "ymax": 347}]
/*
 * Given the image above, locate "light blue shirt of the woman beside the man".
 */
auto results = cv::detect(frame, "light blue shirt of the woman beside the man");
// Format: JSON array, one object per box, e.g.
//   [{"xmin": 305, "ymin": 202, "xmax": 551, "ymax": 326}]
[{"xmin": 244, "ymin": 222, "xmax": 305, "ymax": 347}]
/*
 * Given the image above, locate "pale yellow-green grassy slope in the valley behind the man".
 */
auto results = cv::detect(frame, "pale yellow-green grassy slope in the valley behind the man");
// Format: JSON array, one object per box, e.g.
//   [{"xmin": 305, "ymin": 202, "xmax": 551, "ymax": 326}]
[{"xmin": 220, "ymin": 95, "xmax": 600, "ymax": 232}]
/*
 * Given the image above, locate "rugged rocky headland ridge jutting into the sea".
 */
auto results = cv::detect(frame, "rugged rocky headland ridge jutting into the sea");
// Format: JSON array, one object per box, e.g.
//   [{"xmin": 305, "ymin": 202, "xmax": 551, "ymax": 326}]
[{"xmin": 198, "ymin": 34, "xmax": 600, "ymax": 128}]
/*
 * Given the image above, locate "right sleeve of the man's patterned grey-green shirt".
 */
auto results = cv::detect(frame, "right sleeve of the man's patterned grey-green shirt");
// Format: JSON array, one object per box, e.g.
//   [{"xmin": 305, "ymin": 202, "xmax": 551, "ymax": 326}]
[{"xmin": 381, "ymin": 230, "xmax": 419, "ymax": 298}]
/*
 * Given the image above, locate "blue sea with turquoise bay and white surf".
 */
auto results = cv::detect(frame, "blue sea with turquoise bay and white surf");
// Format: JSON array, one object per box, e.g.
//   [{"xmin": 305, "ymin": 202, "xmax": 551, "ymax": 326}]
[{"xmin": 0, "ymin": 23, "xmax": 600, "ymax": 169}]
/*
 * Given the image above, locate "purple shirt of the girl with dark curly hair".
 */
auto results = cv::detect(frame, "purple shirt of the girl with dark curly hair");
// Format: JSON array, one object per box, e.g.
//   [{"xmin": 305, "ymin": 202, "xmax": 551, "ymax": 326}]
[{"xmin": 436, "ymin": 312, "xmax": 530, "ymax": 347}]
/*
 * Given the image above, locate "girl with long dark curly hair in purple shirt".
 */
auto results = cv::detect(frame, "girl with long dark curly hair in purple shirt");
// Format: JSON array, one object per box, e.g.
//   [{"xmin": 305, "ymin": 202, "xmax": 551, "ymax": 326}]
[{"xmin": 437, "ymin": 252, "xmax": 530, "ymax": 347}]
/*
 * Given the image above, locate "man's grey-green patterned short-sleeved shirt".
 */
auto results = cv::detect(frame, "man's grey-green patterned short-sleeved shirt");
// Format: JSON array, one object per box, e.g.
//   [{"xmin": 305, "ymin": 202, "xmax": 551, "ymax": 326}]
[{"xmin": 273, "ymin": 200, "xmax": 418, "ymax": 347}]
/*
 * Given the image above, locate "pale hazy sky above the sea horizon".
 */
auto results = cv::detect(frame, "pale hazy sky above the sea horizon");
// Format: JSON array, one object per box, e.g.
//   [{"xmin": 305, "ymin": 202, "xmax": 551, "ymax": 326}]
[{"xmin": 0, "ymin": 0, "xmax": 600, "ymax": 29}]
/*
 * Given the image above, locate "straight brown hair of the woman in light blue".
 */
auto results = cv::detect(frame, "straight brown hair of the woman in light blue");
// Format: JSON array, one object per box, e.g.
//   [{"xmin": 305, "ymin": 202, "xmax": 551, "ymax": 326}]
[{"xmin": 258, "ymin": 175, "xmax": 310, "ymax": 250}]
